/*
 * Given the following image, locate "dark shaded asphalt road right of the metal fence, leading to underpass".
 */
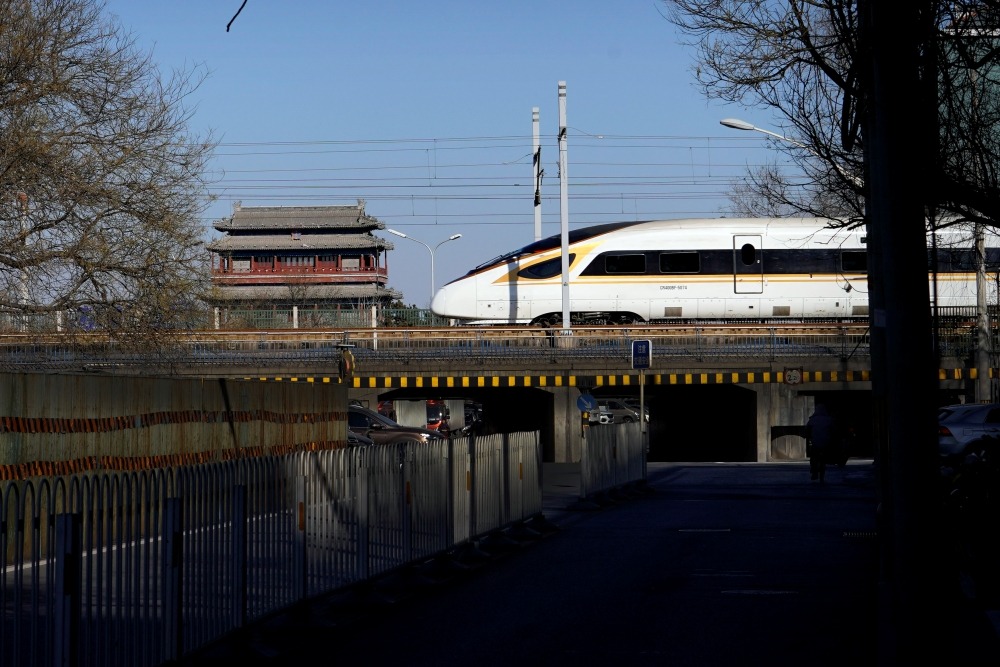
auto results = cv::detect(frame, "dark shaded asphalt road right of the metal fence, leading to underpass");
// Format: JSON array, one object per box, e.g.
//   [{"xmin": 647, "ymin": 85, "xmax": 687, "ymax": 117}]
[{"xmin": 176, "ymin": 460, "xmax": 1000, "ymax": 667}]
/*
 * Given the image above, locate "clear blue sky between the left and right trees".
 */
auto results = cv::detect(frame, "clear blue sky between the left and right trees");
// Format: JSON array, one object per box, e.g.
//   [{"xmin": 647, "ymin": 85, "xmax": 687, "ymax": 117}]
[{"xmin": 107, "ymin": 0, "xmax": 781, "ymax": 306}]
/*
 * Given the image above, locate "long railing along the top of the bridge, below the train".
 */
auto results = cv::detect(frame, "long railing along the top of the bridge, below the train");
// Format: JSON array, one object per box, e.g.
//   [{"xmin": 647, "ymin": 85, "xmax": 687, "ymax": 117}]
[{"xmin": 0, "ymin": 325, "xmax": 888, "ymax": 371}]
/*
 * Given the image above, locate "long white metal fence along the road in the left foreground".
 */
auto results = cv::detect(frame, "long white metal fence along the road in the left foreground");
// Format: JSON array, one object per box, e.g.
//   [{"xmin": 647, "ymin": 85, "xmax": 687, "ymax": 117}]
[{"xmin": 0, "ymin": 432, "xmax": 542, "ymax": 666}]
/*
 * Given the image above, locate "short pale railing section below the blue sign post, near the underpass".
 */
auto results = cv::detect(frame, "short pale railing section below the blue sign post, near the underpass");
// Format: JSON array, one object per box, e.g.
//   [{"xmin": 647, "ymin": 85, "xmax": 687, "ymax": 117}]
[{"xmin": 580, "ymin": 422, "xmax": 648, "ymax": 499}]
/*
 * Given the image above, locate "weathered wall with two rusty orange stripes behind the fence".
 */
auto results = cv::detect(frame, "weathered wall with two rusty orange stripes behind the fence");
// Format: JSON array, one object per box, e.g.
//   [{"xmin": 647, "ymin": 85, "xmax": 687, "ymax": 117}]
[{"xmin": 0, "ymin": 374, "xmax": 347, "ymax": 478}]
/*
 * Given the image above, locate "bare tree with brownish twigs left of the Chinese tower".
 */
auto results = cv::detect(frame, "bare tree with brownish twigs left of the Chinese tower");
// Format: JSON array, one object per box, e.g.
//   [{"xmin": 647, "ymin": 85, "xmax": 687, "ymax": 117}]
[{"xmin": 0, "ymin": 0, "xmax": 214, "ymax": 342}]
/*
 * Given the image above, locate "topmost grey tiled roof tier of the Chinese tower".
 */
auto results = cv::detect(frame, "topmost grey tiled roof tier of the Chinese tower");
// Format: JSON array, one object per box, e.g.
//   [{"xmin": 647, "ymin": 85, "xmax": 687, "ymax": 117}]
[{"xmin": 212, "ymin": 200, "xmax": 385, "ymax": 232}]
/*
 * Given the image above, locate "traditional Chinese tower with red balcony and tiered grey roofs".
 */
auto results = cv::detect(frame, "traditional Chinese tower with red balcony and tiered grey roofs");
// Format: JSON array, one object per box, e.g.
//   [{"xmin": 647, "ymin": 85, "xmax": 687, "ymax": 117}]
[{"xmin": 208, "ymin": 199, "xmax": 402, "ymax": 327}]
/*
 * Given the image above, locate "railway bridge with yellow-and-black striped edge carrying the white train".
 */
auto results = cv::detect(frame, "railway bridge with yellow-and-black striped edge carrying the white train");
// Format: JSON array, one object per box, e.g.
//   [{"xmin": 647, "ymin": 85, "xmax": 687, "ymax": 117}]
[{"xmin": 0, "ymin": 323, "xmax": 994, "ymax": 462}]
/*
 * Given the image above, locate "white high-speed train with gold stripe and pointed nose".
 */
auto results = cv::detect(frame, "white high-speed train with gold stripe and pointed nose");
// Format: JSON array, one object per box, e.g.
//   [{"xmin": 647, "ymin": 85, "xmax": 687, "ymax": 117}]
[{"xmin": 431, "ymin": 218, "xmax": 1000, "ymax": 326}]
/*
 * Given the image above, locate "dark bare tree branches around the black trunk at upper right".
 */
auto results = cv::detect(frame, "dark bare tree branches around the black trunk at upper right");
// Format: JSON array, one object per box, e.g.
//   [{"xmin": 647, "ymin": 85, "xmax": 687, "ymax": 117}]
[{"xmin": 663, "ymin": 0, "xmax": 1000, "ymax": 224}]
